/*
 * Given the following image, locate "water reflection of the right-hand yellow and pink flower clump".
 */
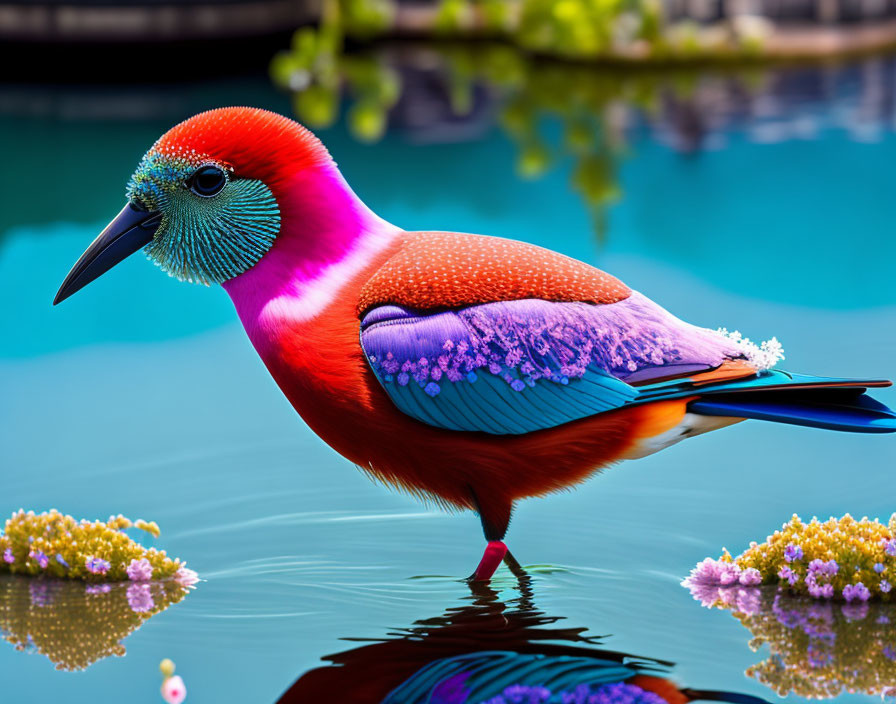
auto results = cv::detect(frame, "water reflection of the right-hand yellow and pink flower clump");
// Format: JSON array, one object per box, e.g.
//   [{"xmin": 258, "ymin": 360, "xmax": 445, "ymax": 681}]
[{"xmin": 691, "ymin": 585, "xmax": 896, "ymax": 699}]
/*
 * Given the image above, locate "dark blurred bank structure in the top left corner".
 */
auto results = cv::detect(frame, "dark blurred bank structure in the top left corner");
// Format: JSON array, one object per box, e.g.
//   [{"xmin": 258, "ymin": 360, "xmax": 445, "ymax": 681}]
[{"xmin": 0, "ymin": 0, "xmax": 320, "ymax": 85}]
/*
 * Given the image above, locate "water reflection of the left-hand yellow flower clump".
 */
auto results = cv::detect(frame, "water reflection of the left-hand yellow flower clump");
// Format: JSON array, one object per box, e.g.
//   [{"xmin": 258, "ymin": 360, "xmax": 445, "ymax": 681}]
[{"xmin": 0, "ymin": 575, "xmax": 188, "ymax": 670}]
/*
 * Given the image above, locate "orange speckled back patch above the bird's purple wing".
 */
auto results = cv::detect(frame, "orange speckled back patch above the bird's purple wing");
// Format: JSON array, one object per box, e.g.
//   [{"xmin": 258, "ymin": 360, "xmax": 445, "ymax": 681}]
[{"xmin": 358, "ymin": 232, "xmax": 631, "ymax": 314}]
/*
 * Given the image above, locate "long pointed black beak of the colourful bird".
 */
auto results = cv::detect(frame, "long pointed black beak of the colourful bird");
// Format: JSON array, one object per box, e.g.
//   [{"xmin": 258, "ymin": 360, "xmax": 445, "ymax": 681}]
[{"xmin": 53, "ymin": 203, "xmax": 162, "ymax": 306}]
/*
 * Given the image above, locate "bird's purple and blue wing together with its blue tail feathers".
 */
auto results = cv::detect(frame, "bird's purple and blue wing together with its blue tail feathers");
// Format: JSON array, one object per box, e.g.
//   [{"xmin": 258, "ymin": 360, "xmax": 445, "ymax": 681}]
[{"xmin": 361, "ymin": 294, "xmax": 896, "ymax": 435}]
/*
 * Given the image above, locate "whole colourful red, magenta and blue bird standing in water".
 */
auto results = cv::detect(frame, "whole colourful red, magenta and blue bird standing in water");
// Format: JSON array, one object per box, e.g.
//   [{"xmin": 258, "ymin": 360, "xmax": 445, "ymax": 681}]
[{"xmin": 55, "ymin": 108, "xmax": 896, "ymax": 579}]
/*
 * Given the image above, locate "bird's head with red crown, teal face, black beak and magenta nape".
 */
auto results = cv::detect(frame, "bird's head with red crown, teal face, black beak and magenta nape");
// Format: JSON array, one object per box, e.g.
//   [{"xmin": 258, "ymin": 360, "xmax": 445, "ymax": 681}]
[{"xmin": 56, "ymin": 107, "xmax": 374, "ymax": 303}]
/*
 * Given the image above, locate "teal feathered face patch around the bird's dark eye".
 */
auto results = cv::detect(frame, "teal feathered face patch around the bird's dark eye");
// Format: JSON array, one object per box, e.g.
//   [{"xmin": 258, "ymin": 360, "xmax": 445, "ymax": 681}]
[{"xmin": 127, "ymin": 152, "xmax": 280, "ymax": 285}]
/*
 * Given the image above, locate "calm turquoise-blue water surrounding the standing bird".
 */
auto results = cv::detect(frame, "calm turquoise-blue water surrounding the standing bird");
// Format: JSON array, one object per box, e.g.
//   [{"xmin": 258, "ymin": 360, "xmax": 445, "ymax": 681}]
[{"xmin": 0, "ymin": 55, "xmax": 896, "ymax": 704}]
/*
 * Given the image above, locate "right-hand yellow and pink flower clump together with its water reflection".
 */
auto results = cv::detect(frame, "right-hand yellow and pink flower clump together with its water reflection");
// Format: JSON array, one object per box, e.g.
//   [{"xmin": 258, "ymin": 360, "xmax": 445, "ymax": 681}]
[{"xmin": 682, "ymin": 514, "xmax": 896, "ymax": 699}]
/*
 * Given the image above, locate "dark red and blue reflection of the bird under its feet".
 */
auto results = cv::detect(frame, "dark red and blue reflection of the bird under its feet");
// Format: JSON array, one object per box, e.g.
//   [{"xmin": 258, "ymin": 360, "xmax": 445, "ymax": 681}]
[{"xmin": 280, "ymin": 576, "xmax": 762, "ymax": 704}]
